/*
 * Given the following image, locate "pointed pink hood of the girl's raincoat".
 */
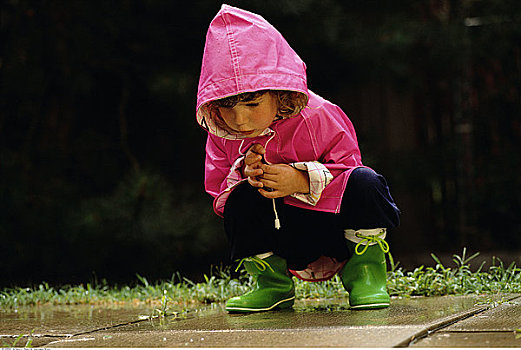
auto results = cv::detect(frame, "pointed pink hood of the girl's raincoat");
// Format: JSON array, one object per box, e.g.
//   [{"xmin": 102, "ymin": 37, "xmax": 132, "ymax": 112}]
[{"xmin": 196, "ymin": 5, "xmax": 309, "ymax": 138}]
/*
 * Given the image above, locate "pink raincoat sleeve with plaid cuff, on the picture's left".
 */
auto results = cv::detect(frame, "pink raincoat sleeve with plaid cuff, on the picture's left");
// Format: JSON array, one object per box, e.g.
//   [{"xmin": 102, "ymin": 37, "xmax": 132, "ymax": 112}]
[{"xmin": 205, "ymin": 134, "xmax": 245, "ymax": 198}]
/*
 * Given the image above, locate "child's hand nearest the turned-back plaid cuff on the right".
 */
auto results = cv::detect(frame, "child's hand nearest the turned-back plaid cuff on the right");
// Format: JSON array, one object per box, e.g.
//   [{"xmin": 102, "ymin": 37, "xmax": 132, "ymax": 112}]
[{"xmin": 255, "ymin": 164, "xmax": 309, "ymax": 198}]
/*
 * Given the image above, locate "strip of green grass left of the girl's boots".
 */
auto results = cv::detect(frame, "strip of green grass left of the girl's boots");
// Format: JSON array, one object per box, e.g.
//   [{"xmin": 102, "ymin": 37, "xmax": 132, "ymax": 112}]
[{"xmin": 0, "ymin": 268, "xmax": 252, "ymax": 308}]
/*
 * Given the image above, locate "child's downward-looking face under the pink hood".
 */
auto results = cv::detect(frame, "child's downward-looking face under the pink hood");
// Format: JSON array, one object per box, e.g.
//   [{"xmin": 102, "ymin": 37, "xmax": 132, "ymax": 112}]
[{"xmin": 218, "ymin": 92, "xmax": 278, "ymax": 137}]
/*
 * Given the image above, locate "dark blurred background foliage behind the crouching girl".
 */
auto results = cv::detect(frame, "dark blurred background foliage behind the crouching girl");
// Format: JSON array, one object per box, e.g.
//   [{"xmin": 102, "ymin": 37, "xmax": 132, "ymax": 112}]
[{"xmin": 0, "ymin": 0, "xmax": 521, "ymax": 284}]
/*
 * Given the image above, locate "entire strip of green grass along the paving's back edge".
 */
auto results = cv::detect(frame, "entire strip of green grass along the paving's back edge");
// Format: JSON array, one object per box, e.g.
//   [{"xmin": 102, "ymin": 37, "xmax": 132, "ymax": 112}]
[{"xmin": 0, "ymin": 249, "xmax": 521, "ymax": 308}]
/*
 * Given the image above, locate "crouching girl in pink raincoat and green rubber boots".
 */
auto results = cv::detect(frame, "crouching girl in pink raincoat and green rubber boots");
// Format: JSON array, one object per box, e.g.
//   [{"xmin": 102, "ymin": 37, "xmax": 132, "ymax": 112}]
[{"xmin": 196, "ymin": 5, "xmax": 399, "ymax": 312}]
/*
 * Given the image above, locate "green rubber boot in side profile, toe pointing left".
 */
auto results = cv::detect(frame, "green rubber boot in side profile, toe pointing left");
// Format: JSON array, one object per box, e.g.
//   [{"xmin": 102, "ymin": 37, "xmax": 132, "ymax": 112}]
[{"xmin": 226, "ymin": 255, "xmax": 295, "ymax": 312}]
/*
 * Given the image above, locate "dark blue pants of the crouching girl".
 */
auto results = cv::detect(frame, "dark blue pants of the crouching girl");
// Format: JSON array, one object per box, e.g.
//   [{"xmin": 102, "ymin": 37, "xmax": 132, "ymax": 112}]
[{"xmin": 224, "ymin": 168, "xmax": 400, "ymax": 270}]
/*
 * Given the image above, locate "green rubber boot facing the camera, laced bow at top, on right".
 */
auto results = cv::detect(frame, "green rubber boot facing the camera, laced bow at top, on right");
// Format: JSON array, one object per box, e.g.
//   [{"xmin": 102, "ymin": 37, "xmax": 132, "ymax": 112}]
[{"xmin": 341, "ymin": 230, "xmax": 390, "ymax": 310}]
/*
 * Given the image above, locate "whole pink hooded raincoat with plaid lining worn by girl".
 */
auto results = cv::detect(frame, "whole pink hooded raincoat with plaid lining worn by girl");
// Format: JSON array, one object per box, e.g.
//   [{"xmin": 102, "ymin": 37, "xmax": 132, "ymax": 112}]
[{"xmin": 196, "ymin": 5, "xmax": 363, "ymax": 279}]
